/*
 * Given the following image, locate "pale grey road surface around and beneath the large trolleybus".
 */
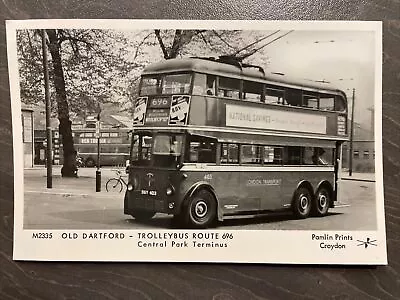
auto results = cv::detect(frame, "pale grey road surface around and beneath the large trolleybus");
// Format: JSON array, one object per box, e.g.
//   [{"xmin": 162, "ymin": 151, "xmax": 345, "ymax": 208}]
[{"xmin": 24, "ymin": 167, "xmax": 383, "ymax": 230}]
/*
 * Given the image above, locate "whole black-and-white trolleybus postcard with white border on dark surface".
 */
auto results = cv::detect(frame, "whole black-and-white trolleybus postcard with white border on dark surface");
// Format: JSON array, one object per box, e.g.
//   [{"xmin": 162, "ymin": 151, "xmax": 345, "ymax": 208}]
[{"xmin": 7, "ymin": 20, "xmax": 387, "ymax": 265}]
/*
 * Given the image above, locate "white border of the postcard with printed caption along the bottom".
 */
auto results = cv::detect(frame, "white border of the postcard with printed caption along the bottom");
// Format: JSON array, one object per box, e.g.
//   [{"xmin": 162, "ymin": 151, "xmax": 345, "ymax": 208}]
[{"xmin": 6, "ymin": 20, "xmax": 387, "ymax": 265}]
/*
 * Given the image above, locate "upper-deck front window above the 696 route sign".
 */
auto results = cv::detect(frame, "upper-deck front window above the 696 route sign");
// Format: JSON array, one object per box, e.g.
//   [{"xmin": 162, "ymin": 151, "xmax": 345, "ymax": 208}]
[{"xmin": 140, "ymin": 74, "xmax": 192, "ymax": 96}]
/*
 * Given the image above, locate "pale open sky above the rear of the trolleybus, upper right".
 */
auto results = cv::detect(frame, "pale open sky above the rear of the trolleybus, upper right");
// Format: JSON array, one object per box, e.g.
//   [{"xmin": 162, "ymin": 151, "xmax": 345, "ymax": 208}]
[{"xmin": 258, "ymin": 31, "xmax": 375, "ymax": 126}]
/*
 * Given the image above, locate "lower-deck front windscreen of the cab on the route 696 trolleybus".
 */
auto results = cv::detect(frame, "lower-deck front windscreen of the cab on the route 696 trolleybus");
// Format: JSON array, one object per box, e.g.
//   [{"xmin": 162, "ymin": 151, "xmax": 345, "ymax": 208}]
[{"xmin": 131, "ymin": 134, "xmax": 183, "ymax": 168}]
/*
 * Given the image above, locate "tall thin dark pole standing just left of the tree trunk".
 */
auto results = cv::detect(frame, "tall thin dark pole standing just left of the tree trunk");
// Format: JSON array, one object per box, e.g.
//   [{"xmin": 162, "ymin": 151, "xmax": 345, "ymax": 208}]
[{"xmin": 41, "ymin": 29, "xmax": 53, "ymax": 189}]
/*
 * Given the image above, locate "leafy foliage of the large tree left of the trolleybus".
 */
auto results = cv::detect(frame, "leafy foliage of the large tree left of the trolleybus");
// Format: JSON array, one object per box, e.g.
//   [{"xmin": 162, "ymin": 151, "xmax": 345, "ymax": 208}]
[{"xmin": 17, "ymin": 29, "xmax": 145, "ymax": 116}]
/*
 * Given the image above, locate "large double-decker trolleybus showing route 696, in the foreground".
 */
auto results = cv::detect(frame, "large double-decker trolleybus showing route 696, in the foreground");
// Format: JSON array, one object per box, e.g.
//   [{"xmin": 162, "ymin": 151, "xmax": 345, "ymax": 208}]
[{"xmin": 124, "ymin": 58, "xmax": 347, "ymax": 228}]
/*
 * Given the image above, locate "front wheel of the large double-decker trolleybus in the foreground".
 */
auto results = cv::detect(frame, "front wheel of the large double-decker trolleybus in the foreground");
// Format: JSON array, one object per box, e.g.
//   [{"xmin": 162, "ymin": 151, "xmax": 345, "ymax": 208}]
[{"xmin": 185, "ymin": 189, "xmax": 217, "ymax": 228}]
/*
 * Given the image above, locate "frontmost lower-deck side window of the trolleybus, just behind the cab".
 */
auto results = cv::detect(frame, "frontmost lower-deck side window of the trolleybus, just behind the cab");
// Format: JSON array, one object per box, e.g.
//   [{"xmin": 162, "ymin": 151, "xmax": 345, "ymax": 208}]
[{"xmin": 185, "ymin": 137, "xmax": 217, "ymax": 163}]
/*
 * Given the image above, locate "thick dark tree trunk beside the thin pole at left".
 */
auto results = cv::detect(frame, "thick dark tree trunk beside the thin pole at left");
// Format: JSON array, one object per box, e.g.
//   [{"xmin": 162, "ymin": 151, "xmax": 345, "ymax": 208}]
[{"xmin": 46, "ymin": 29, "xmax": 77, "ymax": 177}]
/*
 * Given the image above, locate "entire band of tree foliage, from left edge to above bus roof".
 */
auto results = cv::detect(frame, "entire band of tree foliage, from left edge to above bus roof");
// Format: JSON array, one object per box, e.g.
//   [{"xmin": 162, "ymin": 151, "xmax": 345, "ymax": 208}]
[{"xmin": 17, "ymin": 29, "xmax": 276, "ymax": 117}]
